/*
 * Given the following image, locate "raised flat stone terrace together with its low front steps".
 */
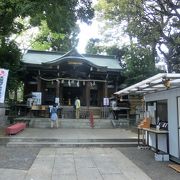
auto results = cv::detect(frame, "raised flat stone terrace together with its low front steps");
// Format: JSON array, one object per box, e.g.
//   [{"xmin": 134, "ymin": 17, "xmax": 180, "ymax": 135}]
[{"xmin": 0, "ymin": 128, "xmax": 137, "ymax": 148}]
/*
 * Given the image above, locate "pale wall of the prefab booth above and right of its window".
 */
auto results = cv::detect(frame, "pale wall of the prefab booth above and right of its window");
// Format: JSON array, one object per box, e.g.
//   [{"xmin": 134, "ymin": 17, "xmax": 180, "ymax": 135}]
[{"xmin": 145, "ymin": 88, "xmax": 180, "ymax": 158}]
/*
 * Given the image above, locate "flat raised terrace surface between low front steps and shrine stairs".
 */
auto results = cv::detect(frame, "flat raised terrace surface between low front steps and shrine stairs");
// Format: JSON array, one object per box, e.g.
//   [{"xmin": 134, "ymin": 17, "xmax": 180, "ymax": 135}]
[{"xmin": 5, "ymin": 128, "xmax": 137, "ymax": 139}]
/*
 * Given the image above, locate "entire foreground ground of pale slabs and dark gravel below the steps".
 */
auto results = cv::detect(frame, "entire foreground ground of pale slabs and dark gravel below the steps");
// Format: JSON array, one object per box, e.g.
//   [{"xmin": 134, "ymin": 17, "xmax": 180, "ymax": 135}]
[{"xmin": 0, "ymin": 146, "xmax": 180, "ymax": 180}]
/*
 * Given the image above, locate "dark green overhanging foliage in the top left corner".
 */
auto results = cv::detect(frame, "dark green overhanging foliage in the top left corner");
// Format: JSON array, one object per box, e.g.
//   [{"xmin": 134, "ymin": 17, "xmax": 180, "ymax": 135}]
[{"xmin": 0, "ymin": 0, "xmax": 94, "ymax": 36}]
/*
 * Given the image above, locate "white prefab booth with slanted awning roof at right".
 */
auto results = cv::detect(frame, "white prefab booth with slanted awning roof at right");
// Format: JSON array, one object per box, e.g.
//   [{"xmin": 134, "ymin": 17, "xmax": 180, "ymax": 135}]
[{"xmin": 115, "ymin": 73, "xmax": 180, "ymax": 163}]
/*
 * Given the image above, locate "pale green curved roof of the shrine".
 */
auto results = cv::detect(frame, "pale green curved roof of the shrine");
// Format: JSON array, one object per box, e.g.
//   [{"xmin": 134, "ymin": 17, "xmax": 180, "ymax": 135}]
[{"xmin": 22, "ymin": 50, "xmax": 122, "ymax": 70}]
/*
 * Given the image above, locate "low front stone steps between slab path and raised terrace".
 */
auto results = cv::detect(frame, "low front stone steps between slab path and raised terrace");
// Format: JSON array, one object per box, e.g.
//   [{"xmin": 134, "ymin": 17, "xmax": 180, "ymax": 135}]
[{"xmin": 3, "ymin": 137, "xmax": 137, "ymax": 148}]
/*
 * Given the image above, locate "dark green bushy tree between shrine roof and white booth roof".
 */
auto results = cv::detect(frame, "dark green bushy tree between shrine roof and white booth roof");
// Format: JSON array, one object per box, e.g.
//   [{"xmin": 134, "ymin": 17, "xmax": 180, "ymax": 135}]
[{"xmin": 121, "ymin": 44, "xmax": 160, "ymax": 85}]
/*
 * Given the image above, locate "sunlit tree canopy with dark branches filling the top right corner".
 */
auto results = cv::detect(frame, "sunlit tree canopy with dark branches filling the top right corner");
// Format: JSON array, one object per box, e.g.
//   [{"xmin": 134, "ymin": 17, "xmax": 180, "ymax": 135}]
[{"xmin": 97, "ymin": 0, "xmax": 180, "ymax": 72}]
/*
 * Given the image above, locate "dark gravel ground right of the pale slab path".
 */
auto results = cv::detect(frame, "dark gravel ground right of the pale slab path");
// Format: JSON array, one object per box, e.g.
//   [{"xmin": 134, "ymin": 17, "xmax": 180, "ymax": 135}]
[{"xmin": 118, "ymin": 147, "xmax": 180, "ymax": 180}]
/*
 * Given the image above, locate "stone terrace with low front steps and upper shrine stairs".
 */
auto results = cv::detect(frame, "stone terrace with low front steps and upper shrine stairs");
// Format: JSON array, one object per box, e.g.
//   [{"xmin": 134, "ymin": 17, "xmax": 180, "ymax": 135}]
[{"xmin": 0, "ymin": 118, "xmax": 138, "ymax": 148}]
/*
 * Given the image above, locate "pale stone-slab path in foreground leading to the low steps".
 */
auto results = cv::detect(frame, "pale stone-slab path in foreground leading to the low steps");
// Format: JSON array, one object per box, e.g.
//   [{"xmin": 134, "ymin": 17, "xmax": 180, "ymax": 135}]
[{"xmin": 0, "ymin": 148, "xmax": 151, "ymax": 180}]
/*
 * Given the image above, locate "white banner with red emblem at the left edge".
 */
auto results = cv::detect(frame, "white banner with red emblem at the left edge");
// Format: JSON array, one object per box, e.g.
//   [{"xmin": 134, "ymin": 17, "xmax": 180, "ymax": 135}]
[{"xmin": 0, "ymin": 69, "xmax": 9, "ymax": 103}]
